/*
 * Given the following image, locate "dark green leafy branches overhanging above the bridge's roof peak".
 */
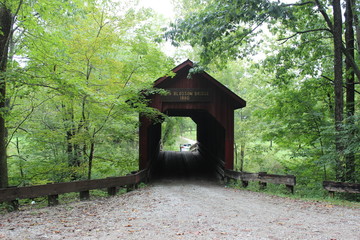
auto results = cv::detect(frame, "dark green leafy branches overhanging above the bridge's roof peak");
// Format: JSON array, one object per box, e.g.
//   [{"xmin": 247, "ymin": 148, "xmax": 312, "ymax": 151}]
[{"xmin": 165, "ymin": 0, "xmax": 290, "ymax": 64}]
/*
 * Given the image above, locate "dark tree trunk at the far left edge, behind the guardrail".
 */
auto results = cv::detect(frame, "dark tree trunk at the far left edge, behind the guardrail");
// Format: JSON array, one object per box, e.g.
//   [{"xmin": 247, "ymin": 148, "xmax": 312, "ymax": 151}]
[{"xmin": 0, "ymin": 5, "xmax": 12, "ymax": 188}]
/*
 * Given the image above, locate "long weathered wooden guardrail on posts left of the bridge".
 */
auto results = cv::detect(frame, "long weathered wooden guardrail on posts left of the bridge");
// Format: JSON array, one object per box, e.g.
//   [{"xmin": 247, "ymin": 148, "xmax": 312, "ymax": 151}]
[{"xmin": 0, "ymin": 169, "xmax": 148, "ymax": 209}]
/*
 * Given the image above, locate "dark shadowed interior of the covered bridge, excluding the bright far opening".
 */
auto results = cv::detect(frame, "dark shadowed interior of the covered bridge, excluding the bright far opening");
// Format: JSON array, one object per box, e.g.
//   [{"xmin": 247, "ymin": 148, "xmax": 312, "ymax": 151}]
[{"xmin": 151, "ymin": 111, "xmax": 224, "ymax": 180}]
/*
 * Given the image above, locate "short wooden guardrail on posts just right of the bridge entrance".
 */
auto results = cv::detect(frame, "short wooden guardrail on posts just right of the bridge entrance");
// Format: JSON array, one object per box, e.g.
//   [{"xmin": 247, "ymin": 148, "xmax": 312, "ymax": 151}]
[{"xmin": 225, "ymin": 169, "xmax": 296, "ymax": 193}]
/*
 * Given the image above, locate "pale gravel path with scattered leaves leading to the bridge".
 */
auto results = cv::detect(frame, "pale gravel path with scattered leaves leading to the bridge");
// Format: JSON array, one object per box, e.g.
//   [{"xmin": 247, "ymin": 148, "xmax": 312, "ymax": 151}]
[{"xmin": 0, "ymin": 180, "xmax": 360, "ymax": 240}]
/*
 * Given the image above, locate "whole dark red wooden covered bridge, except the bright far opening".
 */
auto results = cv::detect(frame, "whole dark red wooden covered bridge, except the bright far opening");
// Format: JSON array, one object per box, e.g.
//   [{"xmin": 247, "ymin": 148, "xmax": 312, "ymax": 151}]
[{"xmin": 139, "ymin": 60, "xmax": 246, "ymax": 179}]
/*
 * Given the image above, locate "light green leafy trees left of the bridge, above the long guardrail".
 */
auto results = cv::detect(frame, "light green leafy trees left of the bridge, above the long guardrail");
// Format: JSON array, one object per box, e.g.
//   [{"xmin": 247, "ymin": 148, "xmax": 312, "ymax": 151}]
[{"xmin": 7, "ymin": 1, "xmax": 173, "ymax": 185}]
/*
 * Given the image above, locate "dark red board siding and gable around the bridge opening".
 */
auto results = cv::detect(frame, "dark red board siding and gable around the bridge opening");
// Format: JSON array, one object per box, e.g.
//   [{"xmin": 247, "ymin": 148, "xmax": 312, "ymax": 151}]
[{"xmin": 139, "ymin": 60, "xmax": 246, "ymax": 172}]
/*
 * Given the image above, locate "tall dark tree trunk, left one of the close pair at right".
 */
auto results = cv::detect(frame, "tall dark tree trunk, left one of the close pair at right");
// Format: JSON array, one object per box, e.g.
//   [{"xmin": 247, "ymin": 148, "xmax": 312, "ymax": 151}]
[{"xmin": 333, "ymin": 0, "xmax": 344, "ymax": 181}]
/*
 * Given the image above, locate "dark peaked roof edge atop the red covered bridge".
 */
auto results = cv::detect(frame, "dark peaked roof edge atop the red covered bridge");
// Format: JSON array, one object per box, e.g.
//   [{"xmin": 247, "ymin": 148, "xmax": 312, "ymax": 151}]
[{"xmin": 154, "ymin": 59, "xmax": 246, "ymax": 109}]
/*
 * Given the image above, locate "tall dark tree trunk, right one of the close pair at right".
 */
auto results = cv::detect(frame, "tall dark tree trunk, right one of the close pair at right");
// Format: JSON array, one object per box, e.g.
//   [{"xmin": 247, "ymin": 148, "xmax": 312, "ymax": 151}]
[{"xmin": 345, "ymin": 0, "xmax": 355, "ymax": 182}]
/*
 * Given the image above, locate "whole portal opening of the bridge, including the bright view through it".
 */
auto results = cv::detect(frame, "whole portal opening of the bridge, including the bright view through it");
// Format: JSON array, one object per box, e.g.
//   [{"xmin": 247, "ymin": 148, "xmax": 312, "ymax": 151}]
[{"xmin": 151, "ymin": 110, "xmax": 225, "ymax": 179}]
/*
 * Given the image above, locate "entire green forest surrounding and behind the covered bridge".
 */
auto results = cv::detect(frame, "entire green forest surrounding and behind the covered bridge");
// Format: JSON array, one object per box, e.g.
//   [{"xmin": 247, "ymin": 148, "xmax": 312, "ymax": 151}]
[{"xmin": 0, "ymin": 0, "xmax": 360, "ymax": 199}]
